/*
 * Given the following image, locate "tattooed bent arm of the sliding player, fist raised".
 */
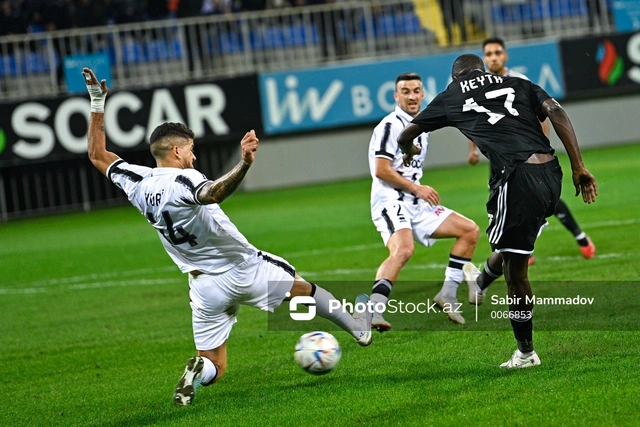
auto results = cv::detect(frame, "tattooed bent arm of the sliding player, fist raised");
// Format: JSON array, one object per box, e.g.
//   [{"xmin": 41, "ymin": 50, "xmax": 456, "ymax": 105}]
[{"xmin": 198, "ymin": 130, "xmax": 260, "ymax": 205}]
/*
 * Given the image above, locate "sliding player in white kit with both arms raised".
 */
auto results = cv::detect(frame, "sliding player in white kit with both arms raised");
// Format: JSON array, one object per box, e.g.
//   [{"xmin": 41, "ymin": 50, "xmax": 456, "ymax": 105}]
[{"xmin": 83, "ymin": 68, "xmax": 371, "ymax": 406}]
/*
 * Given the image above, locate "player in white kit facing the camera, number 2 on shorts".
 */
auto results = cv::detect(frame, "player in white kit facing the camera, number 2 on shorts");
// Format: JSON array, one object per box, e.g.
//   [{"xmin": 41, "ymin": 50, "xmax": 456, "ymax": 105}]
[{"xmin": 369, "ymin": 73, "xmax": 479, "ymax": 332}]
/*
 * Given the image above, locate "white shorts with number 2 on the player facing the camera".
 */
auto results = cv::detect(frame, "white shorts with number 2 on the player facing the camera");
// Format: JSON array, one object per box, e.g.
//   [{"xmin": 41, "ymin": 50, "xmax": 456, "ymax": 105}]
[{"xmin": 371, "ymin": 200, "xmax": 453, "ymax": 247}]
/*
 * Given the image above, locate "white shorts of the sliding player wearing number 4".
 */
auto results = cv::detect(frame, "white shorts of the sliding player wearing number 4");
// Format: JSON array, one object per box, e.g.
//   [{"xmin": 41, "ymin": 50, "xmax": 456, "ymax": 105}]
[{"xmin": 189, "ymin": 251, "xmax": 295, "ymax": 350}]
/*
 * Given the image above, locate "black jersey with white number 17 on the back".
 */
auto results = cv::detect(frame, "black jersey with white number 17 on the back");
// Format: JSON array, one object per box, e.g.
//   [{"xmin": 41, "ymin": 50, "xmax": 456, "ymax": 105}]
[{"xmin": 412, "ymin": 70, "xmax": 554, "ymax": 182}]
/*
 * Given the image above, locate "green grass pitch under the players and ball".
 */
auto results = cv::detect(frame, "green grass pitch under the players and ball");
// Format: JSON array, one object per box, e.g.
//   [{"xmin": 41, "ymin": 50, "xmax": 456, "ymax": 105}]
[{"xmin": 0, "ymin": 145, "xmax": 640, "ymax": 426}]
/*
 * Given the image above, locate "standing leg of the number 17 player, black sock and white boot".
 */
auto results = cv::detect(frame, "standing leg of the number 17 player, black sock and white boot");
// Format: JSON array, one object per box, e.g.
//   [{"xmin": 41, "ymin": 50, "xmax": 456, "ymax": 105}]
[{"xmin": 500, "ymin": 252, "xmax": 540, "ymax": 368}]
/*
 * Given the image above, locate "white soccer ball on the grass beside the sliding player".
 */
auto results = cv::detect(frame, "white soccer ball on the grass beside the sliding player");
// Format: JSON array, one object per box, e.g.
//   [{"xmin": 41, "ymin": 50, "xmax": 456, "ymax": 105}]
[{"xmin": 293, "ymin": 331, "xmax": 342, "ymax": 375}]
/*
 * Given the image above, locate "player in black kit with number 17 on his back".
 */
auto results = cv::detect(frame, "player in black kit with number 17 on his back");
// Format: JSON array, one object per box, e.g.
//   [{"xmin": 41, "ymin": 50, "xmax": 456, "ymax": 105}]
[{"xmin": 398, "ymin": 54, "xmax": 598, "ymax": 368}]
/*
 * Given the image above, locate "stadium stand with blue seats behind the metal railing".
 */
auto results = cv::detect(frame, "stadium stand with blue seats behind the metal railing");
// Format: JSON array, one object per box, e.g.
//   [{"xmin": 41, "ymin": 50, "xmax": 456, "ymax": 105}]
[{"xmin": 0, "ymin": 0, "xmax": 612, "ymax": 100}]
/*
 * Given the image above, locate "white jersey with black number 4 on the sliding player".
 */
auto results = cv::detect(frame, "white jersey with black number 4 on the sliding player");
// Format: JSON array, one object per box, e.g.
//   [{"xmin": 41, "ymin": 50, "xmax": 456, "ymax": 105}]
[{"xmin": 107, "ymin": 159, "xmax": 258, "ymax": 274}]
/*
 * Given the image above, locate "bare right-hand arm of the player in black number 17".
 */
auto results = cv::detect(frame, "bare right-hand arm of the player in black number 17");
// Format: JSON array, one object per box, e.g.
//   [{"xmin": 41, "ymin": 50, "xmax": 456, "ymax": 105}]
[{"xmin": 542, "ymin": 98, "xmax": 598, "ymax": 203}]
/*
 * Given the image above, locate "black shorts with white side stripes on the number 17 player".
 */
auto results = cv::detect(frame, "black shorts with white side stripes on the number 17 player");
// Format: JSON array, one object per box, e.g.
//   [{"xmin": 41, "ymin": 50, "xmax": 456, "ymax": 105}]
[{"xmin": 487, "ymin": 158, "xmax": 562, "ymax": 254}]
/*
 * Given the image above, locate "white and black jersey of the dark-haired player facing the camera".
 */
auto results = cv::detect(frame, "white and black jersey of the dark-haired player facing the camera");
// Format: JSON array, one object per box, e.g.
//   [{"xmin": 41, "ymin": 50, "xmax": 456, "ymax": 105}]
[{"xmin": 369, "ymin": 106, "xmax": 429, "ymax": 212}]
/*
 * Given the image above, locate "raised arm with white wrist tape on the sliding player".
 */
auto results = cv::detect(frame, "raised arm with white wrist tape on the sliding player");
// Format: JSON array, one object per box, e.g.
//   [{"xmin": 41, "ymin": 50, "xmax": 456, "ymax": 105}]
[{"xmin": 82, "ymin": 68, "xmax": 119, "ymax": 175}]
